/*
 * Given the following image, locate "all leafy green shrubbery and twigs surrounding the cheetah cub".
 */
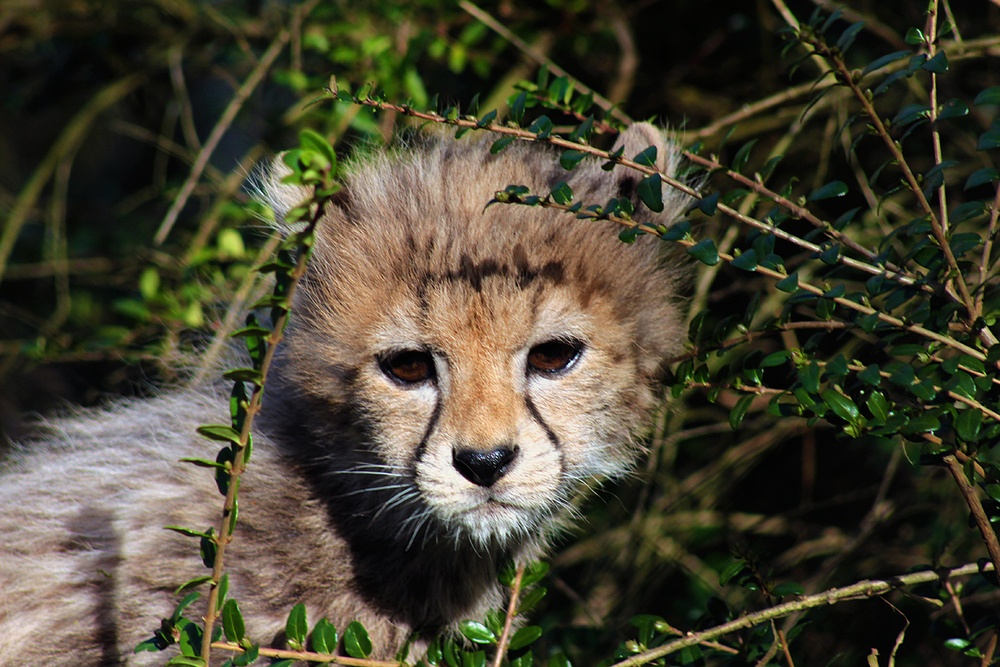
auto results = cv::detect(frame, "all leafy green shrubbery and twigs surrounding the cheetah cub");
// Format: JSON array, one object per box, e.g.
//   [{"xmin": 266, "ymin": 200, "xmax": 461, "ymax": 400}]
[{"xmin": 0, "ymin": 0, "xmax": 1000, "ymax": 667}]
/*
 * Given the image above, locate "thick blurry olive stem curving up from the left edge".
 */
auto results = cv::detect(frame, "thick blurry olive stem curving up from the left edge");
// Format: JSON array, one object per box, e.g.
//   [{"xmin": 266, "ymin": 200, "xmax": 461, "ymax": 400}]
[{"xmin": 0, "ymin": 72, "xmax": 146, "ymax": 279}]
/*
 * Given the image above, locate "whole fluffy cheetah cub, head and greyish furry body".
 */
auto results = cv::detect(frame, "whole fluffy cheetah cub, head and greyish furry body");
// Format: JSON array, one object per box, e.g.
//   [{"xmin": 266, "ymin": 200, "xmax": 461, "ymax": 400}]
[{"xmin": 0, "ymin": 125, "xmax": 682, "ymax": 665}]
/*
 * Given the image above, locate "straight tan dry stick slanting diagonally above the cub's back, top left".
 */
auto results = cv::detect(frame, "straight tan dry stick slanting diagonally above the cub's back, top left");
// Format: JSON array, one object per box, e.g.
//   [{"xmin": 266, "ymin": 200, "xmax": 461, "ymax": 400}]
[{"xmin": 153, "ymin": 0, "xmax": 319, "ymax": 245}]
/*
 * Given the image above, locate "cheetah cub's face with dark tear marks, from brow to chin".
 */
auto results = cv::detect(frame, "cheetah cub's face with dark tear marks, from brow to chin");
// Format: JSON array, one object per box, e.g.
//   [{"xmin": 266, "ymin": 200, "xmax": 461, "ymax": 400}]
[{"xmin": 359, "ymin": 258, "xmax": 636, "ymax": 544}]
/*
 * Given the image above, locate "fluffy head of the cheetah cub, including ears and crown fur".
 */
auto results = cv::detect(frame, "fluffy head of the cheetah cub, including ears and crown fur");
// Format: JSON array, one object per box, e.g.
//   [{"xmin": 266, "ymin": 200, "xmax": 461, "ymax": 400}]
[{"xmin": 271, "ymin": 124, "xmax": 683, "ymax": 548}]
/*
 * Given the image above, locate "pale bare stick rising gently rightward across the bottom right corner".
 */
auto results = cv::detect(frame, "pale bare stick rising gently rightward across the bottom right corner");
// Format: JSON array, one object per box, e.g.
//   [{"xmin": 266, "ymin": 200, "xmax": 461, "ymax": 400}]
[{"xmin": 611, "ymin": 563, "xmax": 995, "ymax": 667}]
